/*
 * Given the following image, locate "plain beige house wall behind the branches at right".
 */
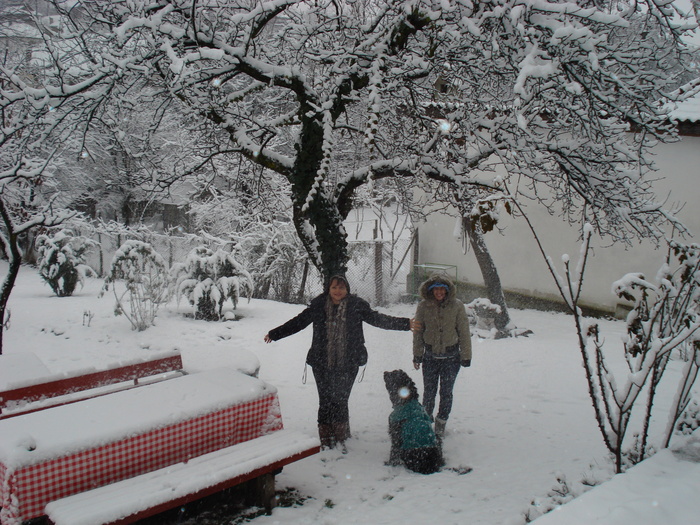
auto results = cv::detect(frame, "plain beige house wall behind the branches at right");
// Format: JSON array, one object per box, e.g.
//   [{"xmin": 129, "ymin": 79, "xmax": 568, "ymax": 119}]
[{"xmin": 417, "ymin": 137, "xmax": 700, "ymax": 312}]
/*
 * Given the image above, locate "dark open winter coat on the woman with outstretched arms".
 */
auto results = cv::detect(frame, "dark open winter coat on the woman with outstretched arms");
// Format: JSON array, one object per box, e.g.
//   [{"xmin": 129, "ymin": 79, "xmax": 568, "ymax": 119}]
[{"xmin": 269, "ymin": 293, "xmax": 411, "ymax": 368}]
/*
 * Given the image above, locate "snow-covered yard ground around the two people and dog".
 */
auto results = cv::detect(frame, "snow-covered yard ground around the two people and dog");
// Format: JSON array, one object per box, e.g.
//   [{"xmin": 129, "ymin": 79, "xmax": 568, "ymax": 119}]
[{"xmin": 0, "ymin": 262, "xmax": 700, "ymax": 525}]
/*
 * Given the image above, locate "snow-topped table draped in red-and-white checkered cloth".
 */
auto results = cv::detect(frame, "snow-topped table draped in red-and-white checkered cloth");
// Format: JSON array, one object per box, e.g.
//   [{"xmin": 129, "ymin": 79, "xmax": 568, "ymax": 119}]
[{"xmin": 0, "ymin": 367, "xmax": 283, "ymax": 525}]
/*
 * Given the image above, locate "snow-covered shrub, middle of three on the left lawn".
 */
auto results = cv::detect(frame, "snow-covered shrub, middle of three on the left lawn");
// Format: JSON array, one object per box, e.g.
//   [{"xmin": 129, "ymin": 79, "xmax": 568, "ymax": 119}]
[{"xmin": 102, "ymin": 240, "xmax": 170, "ymax": 332}]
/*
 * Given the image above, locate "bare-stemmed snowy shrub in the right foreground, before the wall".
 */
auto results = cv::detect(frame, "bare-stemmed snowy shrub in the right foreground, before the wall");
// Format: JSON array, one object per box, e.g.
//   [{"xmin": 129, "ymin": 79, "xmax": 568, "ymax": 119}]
[{"xmin": 533, "ymin": 225, "xmax": 700, "ymax": 472}]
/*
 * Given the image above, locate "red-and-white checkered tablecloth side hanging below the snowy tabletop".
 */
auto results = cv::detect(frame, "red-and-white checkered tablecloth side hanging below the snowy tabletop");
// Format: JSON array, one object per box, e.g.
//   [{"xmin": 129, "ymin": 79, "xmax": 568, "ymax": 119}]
[{"xmin": 0, "ymin": 394, "xmax": 282, "ymax": 525}]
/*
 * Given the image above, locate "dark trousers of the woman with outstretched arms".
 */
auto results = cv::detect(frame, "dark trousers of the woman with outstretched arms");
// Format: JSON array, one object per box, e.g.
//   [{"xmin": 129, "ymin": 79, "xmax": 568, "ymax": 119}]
[{"xmin": 312, "ymin": 367, "xmax": 359, "ymax": 425}]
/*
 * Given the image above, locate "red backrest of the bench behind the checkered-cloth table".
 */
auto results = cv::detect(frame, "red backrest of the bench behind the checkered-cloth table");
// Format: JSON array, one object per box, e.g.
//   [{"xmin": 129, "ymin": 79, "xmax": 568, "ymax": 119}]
[{"xmin": 0, "ymin": 354, "xmax": 183, "ymax": 418}]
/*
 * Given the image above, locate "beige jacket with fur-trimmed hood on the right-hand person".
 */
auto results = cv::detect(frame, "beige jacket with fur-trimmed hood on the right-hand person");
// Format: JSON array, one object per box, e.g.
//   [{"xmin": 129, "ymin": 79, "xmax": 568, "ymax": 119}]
[{"xmin": 413, "ymin": 275, "xmax": 472, "ymax": 362}]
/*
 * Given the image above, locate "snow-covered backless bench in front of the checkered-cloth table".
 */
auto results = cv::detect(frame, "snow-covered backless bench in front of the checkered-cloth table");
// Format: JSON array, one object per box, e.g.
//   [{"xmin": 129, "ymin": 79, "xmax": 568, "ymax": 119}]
[{"xmin": 46, "ymin": 429, "xmax": 319, "ymax": 525}]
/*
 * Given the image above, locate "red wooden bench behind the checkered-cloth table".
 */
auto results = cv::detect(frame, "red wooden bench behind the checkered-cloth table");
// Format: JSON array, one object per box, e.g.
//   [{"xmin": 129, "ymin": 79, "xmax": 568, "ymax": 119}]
[{"xmin": 0, "ymin": 352, "xmax": 184, "ymax": 419}]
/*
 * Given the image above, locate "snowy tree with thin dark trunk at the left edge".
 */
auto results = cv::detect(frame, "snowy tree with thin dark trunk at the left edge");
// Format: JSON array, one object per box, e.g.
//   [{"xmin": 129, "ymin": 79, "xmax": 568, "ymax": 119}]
[{"xmin": 0, "ymin": 6, "xmax": 79, "ymax": 354}]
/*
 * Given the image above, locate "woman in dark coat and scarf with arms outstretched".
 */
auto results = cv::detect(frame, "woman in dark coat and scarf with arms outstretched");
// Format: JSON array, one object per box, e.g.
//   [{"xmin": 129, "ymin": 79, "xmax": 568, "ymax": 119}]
[{"xmin": 265, "ymin": 275, "xmax": 411, "ymax": 448}]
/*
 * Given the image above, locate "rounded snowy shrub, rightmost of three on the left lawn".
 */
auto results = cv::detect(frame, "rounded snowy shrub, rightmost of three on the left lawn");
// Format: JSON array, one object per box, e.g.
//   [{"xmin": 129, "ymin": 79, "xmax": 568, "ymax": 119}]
[{"xmin": 171, "ymin": 247, "xmax": 253, "ymax": 321}]
